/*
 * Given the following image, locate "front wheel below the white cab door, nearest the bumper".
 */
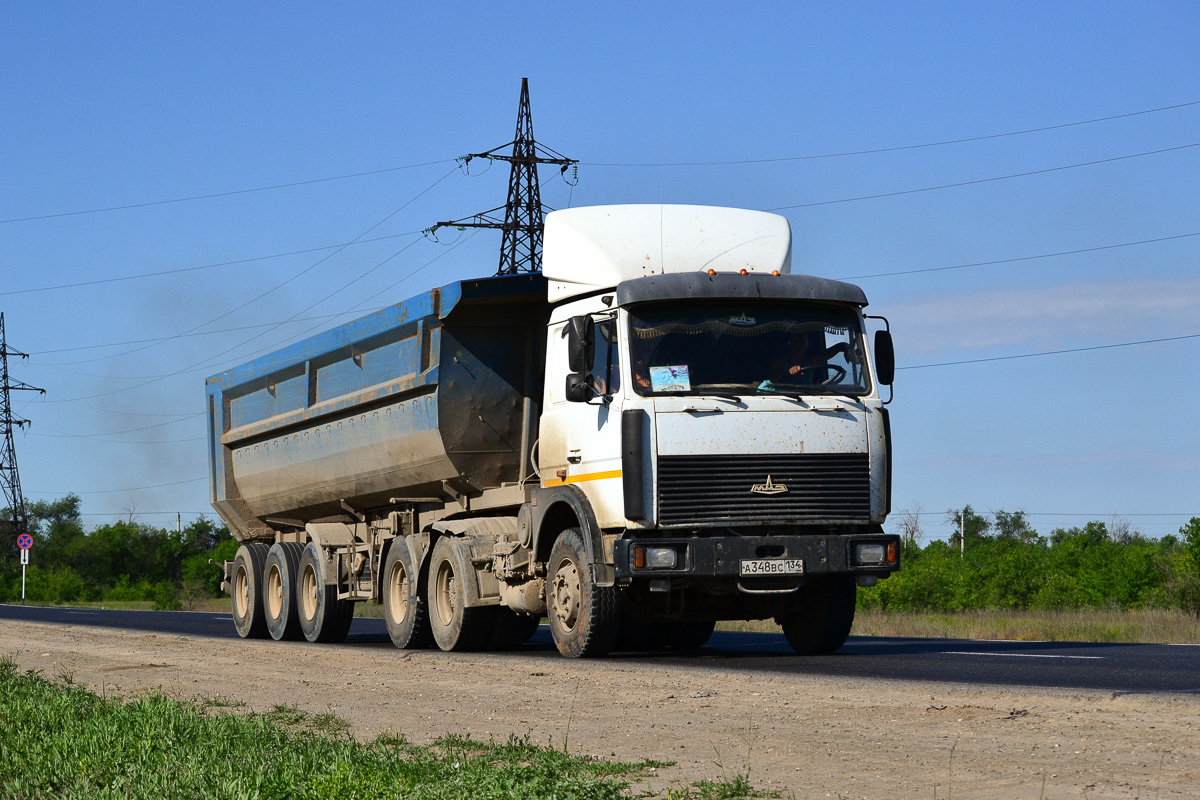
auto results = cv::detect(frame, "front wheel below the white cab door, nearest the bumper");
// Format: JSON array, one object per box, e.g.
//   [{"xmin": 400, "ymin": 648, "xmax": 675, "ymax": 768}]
[{"xmin": 546, "ymin": 528, "xmax": 620, "ymax": 658}]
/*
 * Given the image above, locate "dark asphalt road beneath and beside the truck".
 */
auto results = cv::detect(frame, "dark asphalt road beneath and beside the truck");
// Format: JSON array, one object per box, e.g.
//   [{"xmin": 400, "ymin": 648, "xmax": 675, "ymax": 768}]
[{"xmin": 0, "ymin": 604, "xmax": 1200, "ymax": 694}]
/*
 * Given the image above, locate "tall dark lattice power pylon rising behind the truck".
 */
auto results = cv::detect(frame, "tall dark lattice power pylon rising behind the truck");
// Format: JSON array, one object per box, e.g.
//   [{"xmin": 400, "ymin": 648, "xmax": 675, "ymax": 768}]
[{"xmin": 430, "ymin": 78, "xmax": 580, "ymax": 275}]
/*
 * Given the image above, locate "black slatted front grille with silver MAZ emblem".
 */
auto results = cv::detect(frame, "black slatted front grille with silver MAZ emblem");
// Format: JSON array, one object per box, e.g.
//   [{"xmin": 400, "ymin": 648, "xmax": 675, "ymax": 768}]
[{"xmin": 659, "ymin": 453, "xmax": 871, "ymax": 525}]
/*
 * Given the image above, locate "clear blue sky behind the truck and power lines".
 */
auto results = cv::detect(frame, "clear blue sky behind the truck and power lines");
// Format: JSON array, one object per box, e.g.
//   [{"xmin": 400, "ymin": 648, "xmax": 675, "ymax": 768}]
[{"xmin": 0, "ymin": 2, "xmax": 1200, "ymax": 537}]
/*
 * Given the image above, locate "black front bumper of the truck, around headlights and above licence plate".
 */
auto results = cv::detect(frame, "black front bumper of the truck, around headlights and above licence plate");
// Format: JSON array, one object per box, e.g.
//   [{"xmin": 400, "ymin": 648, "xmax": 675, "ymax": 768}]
[{"xmin": 613, "ymin": 534, "xmax": 900, "ymax": 578}]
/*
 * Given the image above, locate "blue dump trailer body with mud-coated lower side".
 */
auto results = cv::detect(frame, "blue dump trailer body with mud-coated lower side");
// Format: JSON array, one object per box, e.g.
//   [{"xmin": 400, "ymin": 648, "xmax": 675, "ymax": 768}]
[{"xmin": 208, "ymin": 275, "xmax": 547, "ymax": 540}]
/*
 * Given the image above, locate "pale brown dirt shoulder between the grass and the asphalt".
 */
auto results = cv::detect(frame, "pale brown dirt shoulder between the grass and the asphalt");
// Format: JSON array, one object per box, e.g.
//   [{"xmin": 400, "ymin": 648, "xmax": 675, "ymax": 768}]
[{"xmin": 0, "ymin": 621, "xmax": 1200, "ymax": 800}]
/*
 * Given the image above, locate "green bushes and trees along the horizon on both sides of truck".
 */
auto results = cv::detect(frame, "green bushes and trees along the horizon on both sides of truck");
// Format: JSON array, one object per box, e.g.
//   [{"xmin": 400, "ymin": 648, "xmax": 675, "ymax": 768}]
[{"xmin": 0, "ymin": 494, "xmax": 1200, "ymax": 616}]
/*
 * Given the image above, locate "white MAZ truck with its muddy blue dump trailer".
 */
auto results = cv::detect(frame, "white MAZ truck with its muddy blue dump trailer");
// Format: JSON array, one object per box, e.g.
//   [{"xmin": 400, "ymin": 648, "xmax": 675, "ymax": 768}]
[{"xmin": 206, "ymin": 205, "xmax": 900, "ymax": 657}]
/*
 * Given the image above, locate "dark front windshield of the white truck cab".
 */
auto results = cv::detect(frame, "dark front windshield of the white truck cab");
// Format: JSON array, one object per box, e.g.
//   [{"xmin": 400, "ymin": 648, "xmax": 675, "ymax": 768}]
[{"xmin": 629, "ymin": 300, "xmax": 868, "ymax": 396}]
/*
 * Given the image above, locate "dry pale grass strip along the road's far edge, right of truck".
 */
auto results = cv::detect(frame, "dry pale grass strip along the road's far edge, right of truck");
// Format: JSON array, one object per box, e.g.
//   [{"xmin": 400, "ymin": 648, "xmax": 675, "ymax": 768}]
[{"xmin": 718, "ymin": 608, "xmax": 1200, "ymax": 644}]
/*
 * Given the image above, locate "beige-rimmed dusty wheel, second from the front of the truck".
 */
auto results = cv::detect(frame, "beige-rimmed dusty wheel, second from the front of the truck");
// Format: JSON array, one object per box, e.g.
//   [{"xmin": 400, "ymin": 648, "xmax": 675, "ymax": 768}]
[{"xmin": 426, "ymin": 536, "xmax": 497, "ymax": 652}]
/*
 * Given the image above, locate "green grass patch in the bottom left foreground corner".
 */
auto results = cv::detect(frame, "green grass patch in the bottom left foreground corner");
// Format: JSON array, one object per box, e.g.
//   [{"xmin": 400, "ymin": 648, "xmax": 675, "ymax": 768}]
[{"xmin": 0, "ymin": 658, "xmax": 756, "ymax": 800}]
